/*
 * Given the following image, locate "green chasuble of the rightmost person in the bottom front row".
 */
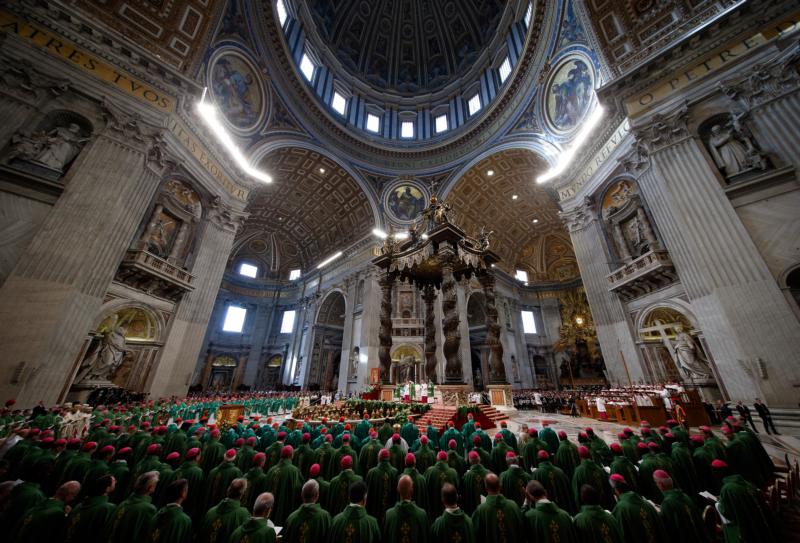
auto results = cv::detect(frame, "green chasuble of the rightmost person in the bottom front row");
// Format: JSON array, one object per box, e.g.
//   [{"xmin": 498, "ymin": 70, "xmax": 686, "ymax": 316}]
[{"xmin": 717, "ymin": 475, "xmax": 778, "ymax": 543}]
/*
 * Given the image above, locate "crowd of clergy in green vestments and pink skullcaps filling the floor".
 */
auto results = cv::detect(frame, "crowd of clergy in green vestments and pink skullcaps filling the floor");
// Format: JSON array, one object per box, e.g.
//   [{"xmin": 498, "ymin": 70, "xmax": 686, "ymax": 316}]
[{"xmin": 0, "ymin": 397, "xmax": 781, "ymax": 543}]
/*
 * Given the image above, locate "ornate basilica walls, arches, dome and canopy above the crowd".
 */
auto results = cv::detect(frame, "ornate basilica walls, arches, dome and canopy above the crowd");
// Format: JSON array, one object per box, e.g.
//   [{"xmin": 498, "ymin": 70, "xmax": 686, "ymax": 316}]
[{"xmin": 0, "ymin": 0, "xmax": 800, "ymax": 420}]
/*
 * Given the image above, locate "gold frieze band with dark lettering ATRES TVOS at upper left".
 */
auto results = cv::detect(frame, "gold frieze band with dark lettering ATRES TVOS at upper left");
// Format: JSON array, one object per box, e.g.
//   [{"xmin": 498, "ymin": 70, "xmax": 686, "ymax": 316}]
[{"xmin": 0, "ymin": 10, "xmax": 175, "ymax": 112}]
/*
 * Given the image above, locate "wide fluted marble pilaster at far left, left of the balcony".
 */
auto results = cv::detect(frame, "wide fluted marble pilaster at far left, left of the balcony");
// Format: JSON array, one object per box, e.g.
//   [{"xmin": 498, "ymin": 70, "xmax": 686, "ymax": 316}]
[{"xmin": 0, "ymin": 110, "xmax": 166, "ymax": 407}]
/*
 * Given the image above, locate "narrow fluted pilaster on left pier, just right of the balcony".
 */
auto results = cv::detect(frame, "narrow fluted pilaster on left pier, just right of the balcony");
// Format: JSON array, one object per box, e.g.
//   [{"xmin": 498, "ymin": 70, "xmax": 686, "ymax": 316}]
[{"xmin": 145, "ymin": 204, "xmax": 246, "ymax": 397}]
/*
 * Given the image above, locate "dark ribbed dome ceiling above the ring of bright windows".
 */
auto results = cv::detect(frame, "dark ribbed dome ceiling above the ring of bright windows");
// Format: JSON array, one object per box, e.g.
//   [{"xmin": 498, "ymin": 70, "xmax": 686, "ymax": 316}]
[{"xmin": 308, "ymin": 0, "xmax": 507, "ymax": 95}]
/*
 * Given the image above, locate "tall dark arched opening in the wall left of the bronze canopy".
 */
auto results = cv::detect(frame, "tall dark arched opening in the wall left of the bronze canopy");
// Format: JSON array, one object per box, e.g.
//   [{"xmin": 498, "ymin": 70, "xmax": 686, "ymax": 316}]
[{"xmin": 304, "ymin": 291, "xmax": 346, "ymax": 390}]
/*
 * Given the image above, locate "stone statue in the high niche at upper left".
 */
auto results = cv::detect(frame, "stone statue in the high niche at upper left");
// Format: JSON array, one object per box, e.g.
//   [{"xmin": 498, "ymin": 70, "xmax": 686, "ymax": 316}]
[{"xmin": 6, "ymin": 123, "xmax": 89, "ymax": 173}]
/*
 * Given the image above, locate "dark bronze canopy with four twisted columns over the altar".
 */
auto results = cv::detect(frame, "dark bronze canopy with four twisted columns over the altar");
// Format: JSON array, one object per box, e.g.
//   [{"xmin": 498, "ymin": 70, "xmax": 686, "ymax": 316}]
[{"xmin": 372, "ymin": 195, "xmax": 511, "ymax": 405}]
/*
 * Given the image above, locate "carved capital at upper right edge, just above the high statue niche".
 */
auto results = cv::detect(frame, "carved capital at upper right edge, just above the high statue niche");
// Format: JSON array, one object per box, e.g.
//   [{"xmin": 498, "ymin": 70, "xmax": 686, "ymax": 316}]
[{"xmin": 719, "ymin": 40, "xmax": 800, "ymax": 111}]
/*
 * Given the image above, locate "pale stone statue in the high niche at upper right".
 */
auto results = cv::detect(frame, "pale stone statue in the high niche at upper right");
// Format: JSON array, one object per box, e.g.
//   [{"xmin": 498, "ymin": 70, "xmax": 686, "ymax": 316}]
[{"xmin": 708, "ymin": 113, "xmax": 767, "ymax": 179}]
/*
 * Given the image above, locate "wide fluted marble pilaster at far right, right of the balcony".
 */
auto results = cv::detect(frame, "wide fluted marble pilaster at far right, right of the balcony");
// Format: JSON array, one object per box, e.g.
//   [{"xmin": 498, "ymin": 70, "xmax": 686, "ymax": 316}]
[{"xmin": 637, "ymin": 110, "xmax": 800, "ymax": 407}]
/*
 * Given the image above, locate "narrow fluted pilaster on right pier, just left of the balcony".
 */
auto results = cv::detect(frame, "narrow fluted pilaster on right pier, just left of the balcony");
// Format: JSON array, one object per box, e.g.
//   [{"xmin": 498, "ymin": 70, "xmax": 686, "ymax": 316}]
[{"xmin": 564, "ymin": 203, "xmax": 644, "ymax": 385}]
